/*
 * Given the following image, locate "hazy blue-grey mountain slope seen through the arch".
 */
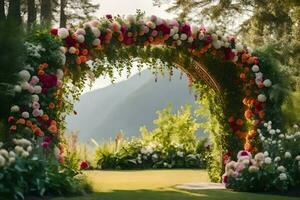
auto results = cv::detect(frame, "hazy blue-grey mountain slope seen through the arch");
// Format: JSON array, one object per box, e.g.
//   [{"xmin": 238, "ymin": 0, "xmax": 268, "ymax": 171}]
[{"xmin": 66, "ymin": 70, "xmax": 202, "ymax": 141}]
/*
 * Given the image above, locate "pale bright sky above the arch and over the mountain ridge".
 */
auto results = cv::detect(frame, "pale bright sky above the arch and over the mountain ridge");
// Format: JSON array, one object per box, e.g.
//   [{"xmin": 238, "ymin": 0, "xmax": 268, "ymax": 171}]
[{"xmin": 84, "ymin": 0, "xmax": 175, "ymax": 93}]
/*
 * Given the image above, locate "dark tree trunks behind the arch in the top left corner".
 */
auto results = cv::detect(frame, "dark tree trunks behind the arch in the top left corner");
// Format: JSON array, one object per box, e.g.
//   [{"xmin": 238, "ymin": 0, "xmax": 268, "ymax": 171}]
[{"xmin": 0, "ymin": 0, "xmax": 99, "ymax": 27}]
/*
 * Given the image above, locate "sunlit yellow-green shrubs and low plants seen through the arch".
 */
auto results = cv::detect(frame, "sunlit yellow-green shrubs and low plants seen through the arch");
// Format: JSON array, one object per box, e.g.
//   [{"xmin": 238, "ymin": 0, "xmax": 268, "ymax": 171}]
[{"xmin": 96, "ymin": 106, "xmax": 210, "ymax": 169}]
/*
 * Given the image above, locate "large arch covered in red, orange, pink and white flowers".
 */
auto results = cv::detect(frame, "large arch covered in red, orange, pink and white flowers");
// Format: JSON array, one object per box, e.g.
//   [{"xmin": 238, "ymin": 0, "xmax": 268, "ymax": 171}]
[{"xmin": 8, "ymin": 14, "xmax": 282, "ymax": 180}]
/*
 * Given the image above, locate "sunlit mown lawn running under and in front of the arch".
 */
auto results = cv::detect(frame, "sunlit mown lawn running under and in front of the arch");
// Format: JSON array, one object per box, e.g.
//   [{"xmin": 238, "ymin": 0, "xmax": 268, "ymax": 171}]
[{"xmin": 53, "ymin": 170, "xmax": 300, "ymax": 200}]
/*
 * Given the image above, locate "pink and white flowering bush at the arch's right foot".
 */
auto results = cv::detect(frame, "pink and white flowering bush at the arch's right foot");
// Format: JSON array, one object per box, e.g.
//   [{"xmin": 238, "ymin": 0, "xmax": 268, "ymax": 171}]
[{"xmin": 223, "ymin": 121, "xmax": 300, "ymax": 192}]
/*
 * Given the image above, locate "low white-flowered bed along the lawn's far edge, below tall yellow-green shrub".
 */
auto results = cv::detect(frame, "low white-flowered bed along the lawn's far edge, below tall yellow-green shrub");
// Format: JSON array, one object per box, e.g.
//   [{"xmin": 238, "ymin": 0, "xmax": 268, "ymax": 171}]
[{"xmin": 96, "ymin": 138, "xmax": 209, "ymax": 169}]
